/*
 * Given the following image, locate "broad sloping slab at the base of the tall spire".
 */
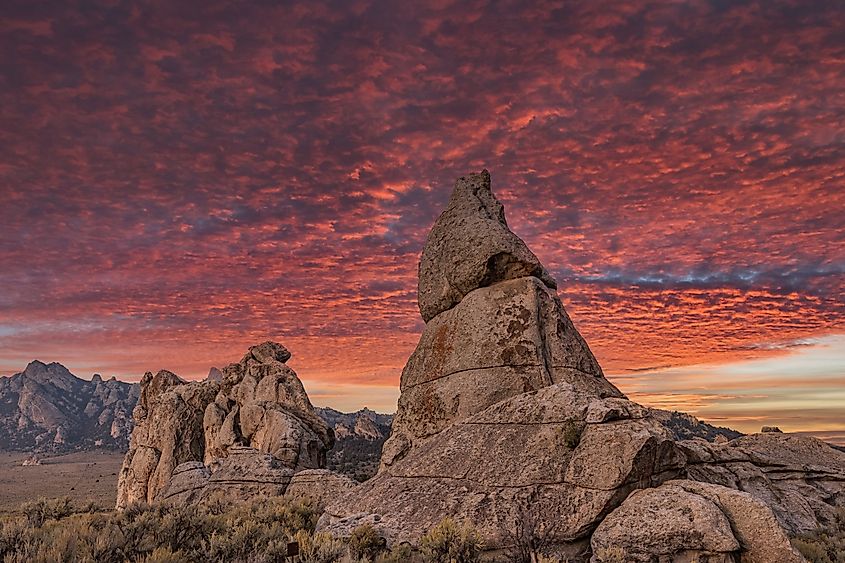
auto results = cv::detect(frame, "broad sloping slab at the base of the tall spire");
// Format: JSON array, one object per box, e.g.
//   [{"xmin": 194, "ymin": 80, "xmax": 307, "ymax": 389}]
[{"xmin": 320, "ymin": 382, "xmax": 684, "ymax": 548}]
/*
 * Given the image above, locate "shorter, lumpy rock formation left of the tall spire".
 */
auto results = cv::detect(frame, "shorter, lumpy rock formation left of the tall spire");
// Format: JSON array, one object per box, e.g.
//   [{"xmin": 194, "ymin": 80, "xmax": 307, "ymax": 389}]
[{"xmin": 117, "ymin": 342, "xmax": 334, "ymax": 509}]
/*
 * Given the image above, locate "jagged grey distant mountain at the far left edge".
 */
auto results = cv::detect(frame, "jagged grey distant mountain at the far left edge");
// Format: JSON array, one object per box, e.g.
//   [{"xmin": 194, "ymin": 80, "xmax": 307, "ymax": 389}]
[{"xmin": 0, "ymin": 361, "xmax": 139, "ymax": 451}]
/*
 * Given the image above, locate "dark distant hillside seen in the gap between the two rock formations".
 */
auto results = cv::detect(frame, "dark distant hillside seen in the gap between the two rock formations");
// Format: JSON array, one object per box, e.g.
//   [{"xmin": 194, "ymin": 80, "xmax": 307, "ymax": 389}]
[{"xmin": 315, "ymin": 408, "xmax": 393, "ymax": 481}]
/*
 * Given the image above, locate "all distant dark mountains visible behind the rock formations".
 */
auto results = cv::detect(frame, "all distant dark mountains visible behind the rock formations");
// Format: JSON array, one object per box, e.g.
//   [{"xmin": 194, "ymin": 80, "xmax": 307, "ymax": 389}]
[{"xmin": 0, "ymin": 361, "xmax": 742, "ymax": 481}]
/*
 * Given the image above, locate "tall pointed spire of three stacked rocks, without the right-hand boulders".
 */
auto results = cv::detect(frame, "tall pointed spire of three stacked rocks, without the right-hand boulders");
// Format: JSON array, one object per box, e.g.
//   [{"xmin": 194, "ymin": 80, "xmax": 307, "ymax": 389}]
[{"xmin": 320, "ymin": 172, "xmax": 685, "ymax": 549}]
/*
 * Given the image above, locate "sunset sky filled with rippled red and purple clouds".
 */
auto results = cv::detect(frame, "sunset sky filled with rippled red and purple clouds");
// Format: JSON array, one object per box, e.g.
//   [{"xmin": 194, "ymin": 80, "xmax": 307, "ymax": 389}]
[{"xmin": 0, "ymin": 0, "xmax": 845, "ymax": 440}]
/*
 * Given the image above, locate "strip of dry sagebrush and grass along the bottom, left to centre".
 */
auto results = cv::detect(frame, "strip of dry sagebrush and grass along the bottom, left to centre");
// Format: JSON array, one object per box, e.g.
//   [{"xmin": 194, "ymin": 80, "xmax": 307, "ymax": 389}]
[{"xmin": 0, "ymin": 497, "xmax": 482, "ymax": 563}]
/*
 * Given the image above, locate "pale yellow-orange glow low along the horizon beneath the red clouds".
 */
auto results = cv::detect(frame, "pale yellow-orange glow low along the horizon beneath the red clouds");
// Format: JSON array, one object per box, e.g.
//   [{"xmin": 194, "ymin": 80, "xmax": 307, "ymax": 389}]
[{"xmin": 3, "ymin": 334, "xmax": 845, "ymax": 445}]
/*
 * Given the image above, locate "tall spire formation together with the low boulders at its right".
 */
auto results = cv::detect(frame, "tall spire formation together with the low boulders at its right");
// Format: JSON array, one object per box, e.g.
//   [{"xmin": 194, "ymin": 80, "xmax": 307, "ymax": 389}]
[{"xmin": 318, "ymin": 171, "xmax": 845, "ymax": 562}]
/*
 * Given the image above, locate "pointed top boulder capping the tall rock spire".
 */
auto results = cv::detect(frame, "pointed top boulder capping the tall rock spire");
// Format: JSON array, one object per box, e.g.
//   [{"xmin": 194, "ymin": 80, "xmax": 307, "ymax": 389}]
[{"xmin": 419, "ymin": 170, "xmax": 556, "ymax": 322}]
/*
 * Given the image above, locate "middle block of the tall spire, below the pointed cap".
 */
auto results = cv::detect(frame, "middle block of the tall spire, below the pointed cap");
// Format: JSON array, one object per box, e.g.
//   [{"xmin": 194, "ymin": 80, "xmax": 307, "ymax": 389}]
[{"xmin": 382, "ymin": 277, "xmax": 622, "ymax": 465}]
